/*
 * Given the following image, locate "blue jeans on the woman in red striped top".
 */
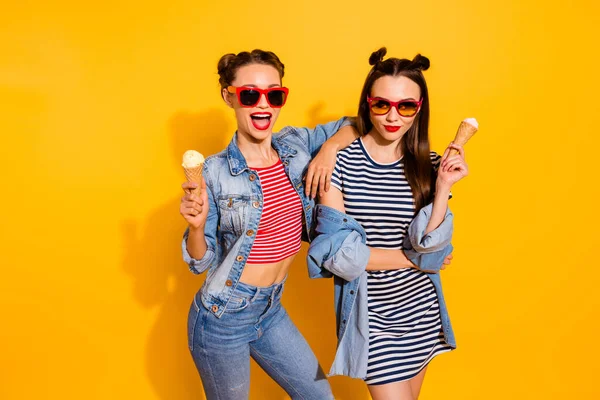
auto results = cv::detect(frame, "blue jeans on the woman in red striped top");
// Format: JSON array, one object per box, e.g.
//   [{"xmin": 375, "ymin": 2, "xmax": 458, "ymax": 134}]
[{"xmin": 188, "ymin": 282, "xmax": 333, "ymax": 400}]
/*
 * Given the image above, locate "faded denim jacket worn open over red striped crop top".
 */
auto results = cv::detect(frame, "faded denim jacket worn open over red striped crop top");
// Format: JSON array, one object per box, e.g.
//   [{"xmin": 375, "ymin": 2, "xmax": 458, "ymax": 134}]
[{"xmin": 182, "ymin": 118, "xmax": 350, "ymax": 318}]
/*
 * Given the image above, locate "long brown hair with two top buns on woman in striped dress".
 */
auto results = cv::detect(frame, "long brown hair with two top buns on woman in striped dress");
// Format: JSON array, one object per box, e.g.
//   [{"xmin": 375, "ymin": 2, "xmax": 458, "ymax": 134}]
[{"xmin": 357, "ymin": 47, "xmax": 436, "ymax": 211}]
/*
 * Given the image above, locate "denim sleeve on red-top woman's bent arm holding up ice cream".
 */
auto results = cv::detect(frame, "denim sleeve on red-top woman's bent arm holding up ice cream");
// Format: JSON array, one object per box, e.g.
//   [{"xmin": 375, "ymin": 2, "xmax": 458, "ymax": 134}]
[{"xmin": 181, "ymin": 163, "xmax": 219, "ymax": 274}]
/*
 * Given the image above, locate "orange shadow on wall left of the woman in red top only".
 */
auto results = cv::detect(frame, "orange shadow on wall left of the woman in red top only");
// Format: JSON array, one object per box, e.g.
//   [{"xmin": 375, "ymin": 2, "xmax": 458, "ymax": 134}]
[{"xmin": 122, "ymin": 109, "xmax": 231, "ymax": 400}]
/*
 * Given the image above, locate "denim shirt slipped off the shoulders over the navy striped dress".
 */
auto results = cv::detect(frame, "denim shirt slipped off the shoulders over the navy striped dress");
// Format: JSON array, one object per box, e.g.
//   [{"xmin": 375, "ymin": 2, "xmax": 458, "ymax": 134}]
[{"xmin": 307, "ymin": 204, "xmax": 456, "ymax": 379}]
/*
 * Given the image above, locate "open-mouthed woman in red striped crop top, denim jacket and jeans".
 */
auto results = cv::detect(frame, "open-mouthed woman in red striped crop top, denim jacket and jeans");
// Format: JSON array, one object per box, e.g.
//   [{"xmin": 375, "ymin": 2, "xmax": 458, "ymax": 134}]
[{"xmin": 180, "ymin": 50, "xmax": 358, "ymax": 400}]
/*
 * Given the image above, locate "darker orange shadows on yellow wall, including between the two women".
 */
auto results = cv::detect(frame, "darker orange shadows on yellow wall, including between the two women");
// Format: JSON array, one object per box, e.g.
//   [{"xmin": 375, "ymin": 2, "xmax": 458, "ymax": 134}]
[{"xmin": 122, "ymin": 103, "xmax": 368, "ymax": 400}]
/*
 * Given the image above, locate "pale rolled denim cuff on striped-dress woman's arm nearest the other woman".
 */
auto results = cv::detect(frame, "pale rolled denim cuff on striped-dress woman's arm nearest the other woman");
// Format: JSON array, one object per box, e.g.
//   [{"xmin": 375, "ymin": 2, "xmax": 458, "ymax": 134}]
[{"xmin": 323, "ymin": 231, "xmax": 371, "ymax": 282}]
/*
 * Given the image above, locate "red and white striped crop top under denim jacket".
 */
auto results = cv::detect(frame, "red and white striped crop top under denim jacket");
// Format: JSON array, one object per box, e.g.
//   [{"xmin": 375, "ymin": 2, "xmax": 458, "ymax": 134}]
[{"xmin": 246, "ymin": 160, "xmax": 302, "ymax": 264}]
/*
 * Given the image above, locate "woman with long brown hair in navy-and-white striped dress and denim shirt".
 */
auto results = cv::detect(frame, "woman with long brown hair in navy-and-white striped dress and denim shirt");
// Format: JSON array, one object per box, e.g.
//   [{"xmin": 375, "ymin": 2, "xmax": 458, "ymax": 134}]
[{"xmin": 309, "ymin": 48, "xmax": 467, "ymax": 400}]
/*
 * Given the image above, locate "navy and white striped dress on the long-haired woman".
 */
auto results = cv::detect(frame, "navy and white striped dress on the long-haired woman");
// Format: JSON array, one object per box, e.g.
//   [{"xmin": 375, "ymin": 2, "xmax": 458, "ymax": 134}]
[{"xmin": 331, "ymin": 139, "xmax": 452, "ymax": 385}]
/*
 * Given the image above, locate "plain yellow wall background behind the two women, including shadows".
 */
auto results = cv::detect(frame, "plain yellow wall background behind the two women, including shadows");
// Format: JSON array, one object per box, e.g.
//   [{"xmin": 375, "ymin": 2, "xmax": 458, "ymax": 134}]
[{"xmin": 0, "ymin": 0, "xmax": 600, "ymax": 400}]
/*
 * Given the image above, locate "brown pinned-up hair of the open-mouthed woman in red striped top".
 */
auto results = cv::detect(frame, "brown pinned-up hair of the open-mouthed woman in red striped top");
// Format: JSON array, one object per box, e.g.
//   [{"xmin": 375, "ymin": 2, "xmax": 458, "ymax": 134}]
[{"xmin": 217, "ymin": 49, "xmax": 284, "ymax": 89}]
